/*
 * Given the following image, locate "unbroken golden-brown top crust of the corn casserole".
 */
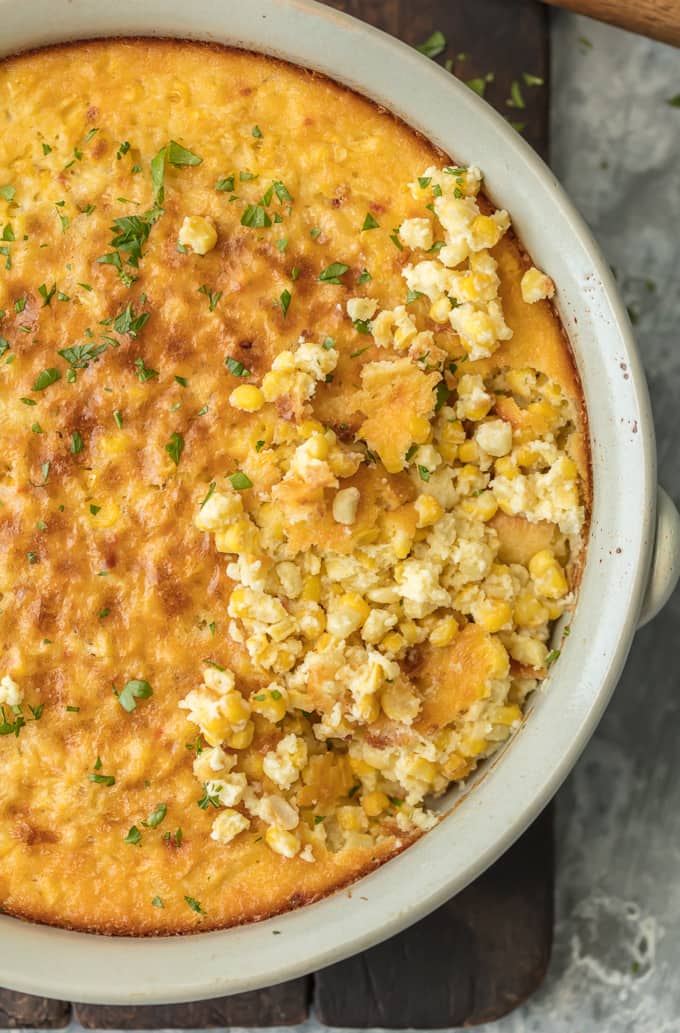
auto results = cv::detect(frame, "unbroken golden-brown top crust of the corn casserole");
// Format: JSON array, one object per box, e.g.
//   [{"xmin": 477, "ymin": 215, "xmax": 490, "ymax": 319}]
[{"xmin": 0, "ymin": 40, "xmax": 585, "ymax": 935}]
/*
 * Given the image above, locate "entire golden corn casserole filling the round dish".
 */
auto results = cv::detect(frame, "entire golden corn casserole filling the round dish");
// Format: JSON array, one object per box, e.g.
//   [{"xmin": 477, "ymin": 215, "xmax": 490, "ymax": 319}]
[{"xmin": 0, "ymin": 40, "xmax": 590, "ymax": 934}]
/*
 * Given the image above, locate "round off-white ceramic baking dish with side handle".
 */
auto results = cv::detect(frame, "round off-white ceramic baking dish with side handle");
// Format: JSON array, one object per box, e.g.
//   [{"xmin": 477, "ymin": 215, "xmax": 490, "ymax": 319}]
[{"xmin": 0, "ymin": 0, "xmax": 680, "ymax": 1004}]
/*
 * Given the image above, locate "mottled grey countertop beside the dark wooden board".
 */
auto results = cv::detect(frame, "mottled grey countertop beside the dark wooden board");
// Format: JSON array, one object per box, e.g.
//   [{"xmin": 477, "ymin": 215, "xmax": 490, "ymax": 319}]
[{"xmin": 19, "ymin": 12, "xmax": 680, "ymax": 1033}]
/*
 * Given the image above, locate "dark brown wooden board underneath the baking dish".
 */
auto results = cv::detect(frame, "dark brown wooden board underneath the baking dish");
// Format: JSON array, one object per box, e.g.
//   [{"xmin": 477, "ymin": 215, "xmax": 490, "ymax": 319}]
[{"xmin": 0, "ymin": 0, "xmax": 554, "ymax": 1029}]
